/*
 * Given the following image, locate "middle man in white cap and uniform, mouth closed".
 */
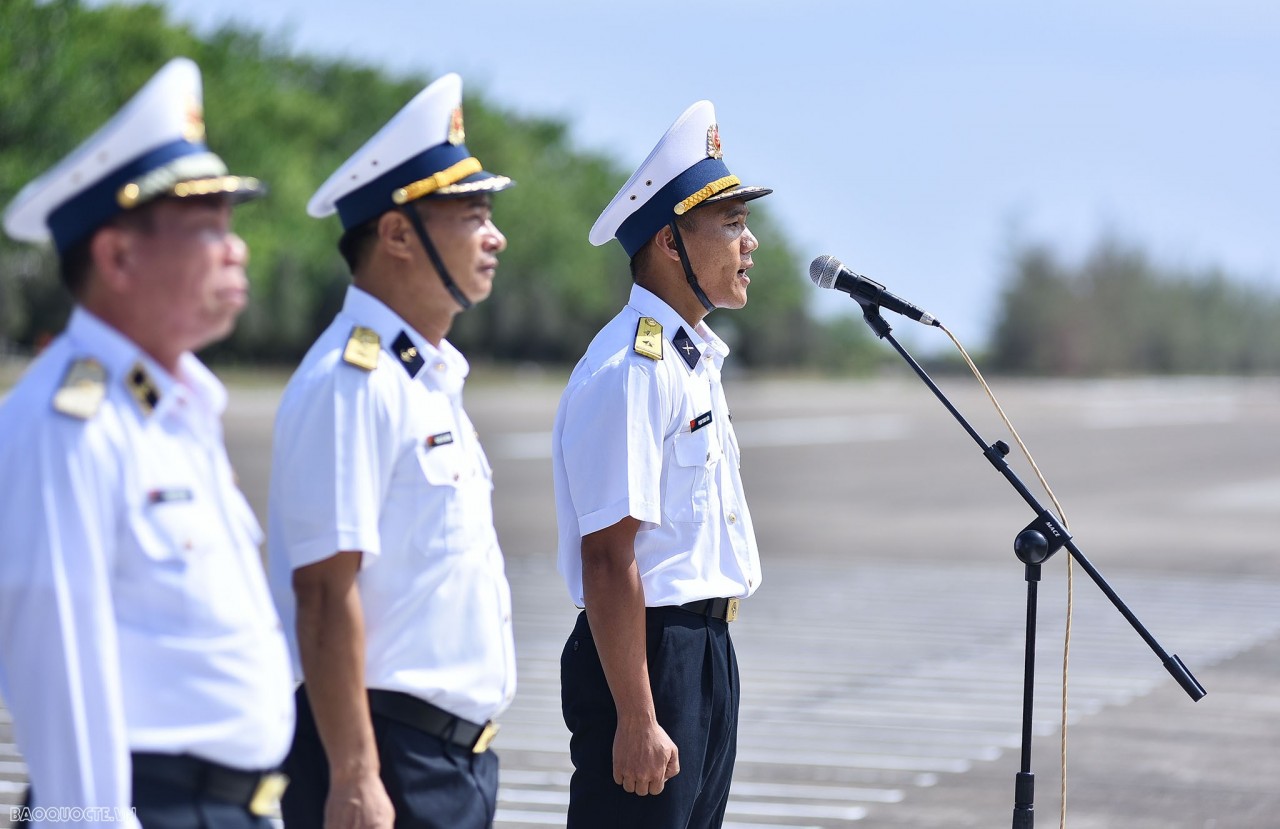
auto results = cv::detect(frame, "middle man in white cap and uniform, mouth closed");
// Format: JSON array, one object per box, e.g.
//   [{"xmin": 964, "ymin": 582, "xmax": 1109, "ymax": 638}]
[{"xmin": 269, "ymin": 74, "xmax": 516, "ymax": 829}]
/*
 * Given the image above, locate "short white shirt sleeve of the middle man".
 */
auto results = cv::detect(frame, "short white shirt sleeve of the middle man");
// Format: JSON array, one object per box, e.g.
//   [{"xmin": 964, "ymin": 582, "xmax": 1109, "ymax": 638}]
[{"xmin": 270, "ymin": 365, "xmax": 397, "ymax": 569}]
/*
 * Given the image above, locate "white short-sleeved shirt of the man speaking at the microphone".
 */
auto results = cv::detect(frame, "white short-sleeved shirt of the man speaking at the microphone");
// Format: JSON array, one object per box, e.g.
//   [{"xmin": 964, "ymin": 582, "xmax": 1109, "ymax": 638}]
[{"xmin": 552, "ymin": 285, "xmax": 760, "ymax": 608}]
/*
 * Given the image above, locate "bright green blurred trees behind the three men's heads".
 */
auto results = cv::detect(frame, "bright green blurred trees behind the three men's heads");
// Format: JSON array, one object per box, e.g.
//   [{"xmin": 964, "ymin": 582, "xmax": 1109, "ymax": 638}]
[{"xmin": 0, "ymin": 0, "xmax": 839, "ymax": 366}]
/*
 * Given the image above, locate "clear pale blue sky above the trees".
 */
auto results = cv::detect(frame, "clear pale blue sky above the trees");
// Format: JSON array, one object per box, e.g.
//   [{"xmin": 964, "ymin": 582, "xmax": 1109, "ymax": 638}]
[{"xmin": 99, "ymin": 0, "xmax": 1280, "ymax": 345}]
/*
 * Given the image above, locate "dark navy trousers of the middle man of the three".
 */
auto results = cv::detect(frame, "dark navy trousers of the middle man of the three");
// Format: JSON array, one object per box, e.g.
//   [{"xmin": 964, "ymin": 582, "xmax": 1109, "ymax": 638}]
[{"xmin": 280, "ymin": 688, "xmax": 498, "ymax": 829}]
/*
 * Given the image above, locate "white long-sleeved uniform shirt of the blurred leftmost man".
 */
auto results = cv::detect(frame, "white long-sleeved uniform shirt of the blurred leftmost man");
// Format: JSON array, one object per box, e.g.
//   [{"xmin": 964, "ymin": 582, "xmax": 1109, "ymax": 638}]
[{"xmin": 0, "ymin": 308, "xmax": 293, "ymax": 826}]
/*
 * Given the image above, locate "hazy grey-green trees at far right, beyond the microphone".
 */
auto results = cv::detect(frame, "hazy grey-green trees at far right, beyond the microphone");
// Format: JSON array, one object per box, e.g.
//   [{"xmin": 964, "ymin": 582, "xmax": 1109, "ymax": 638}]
[{"xmin": 987, "ymin": 237, "xmax": 1280, "ymax": 376}]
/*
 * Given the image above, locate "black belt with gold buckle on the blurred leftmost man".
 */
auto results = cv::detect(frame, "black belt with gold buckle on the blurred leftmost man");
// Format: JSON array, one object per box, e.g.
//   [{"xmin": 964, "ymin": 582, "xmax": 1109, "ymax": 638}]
[{"xmin": 132, "ymin": 752, "xmax": 289, "ymax": 815}]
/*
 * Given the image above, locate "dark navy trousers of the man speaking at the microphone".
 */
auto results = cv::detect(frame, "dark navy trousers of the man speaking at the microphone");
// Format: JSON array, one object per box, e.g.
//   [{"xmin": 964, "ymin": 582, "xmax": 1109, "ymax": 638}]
[{"xmin": 561, "ymin": 608, "xmax": 739, "ymax": 829}]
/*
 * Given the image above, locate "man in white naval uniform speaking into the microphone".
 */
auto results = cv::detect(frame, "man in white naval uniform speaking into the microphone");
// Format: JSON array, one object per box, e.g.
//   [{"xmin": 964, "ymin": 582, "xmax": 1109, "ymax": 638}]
[{"xmin": 552, "ymin": 101, "xmax": 771, "ymax": 829}]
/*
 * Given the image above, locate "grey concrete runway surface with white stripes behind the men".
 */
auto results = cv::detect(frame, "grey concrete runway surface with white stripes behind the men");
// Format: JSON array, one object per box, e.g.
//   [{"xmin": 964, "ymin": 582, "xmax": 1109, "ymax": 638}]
[{"xmin": 0, "ymin": 370, "xmax": 1280, "ymax": 829}]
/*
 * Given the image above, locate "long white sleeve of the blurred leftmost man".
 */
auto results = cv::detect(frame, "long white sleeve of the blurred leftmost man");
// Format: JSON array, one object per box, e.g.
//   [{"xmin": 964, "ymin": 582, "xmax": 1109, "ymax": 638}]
[{"xmin": 0, "ymin": 420, "xmax": 136, "ymax": 829}]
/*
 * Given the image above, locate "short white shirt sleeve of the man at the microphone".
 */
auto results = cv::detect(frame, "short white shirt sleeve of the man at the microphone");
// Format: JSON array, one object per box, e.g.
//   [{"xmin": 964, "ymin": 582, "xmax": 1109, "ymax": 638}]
[{"xmin": 561, "ymin": 359, "xmax": 671, "ymax": 536}]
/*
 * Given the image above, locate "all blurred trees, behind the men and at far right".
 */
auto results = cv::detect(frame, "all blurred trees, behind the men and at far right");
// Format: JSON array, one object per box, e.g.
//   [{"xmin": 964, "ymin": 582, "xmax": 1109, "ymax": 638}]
[{"xmin": 0, "ymin": 0, "xmax": 1280, "ymax": 375}]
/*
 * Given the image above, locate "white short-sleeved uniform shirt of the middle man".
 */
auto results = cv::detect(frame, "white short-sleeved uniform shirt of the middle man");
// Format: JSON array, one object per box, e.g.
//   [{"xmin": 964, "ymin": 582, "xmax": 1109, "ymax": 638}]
[{"xmin": 268, "ymin": 287, "xmax": 516, "ymax": 723}]
